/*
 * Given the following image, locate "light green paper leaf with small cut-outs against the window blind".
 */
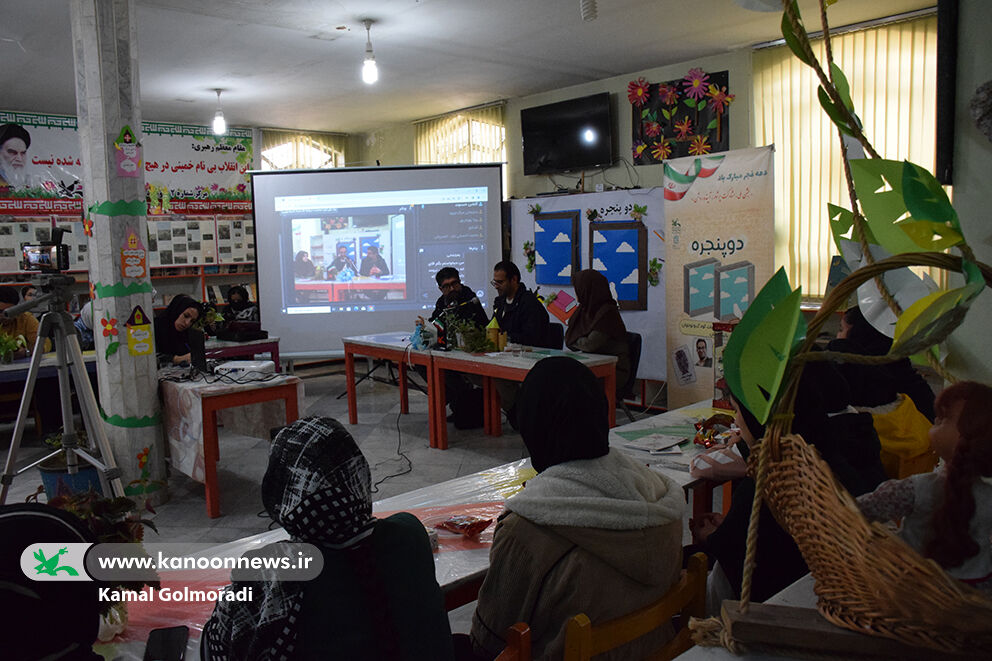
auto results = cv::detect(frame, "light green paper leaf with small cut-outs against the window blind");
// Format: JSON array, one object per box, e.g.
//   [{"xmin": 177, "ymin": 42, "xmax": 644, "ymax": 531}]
[{"xmin": 851, "ymin": 158, "xmax": 932, "ymax": 255}]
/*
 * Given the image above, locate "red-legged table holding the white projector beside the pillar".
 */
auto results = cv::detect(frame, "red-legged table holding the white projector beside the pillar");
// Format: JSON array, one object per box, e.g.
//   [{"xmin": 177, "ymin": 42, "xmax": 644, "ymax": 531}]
[{"xmin": 159, "ymin": 370, "xmax": 303, "ymax": 519}]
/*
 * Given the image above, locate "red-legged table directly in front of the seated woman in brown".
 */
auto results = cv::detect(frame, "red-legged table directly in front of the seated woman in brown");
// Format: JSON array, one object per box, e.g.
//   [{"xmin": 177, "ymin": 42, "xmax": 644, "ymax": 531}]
[{"xmin": 428, "ymin": 349, "xmax": 617, "ymax": 450}]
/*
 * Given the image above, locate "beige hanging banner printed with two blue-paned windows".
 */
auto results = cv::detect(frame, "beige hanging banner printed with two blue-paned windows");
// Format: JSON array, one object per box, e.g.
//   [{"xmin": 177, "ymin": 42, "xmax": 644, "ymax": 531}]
[{"xmin": 664, "ymin": 146, "xmax": 775, "ymax": 408}]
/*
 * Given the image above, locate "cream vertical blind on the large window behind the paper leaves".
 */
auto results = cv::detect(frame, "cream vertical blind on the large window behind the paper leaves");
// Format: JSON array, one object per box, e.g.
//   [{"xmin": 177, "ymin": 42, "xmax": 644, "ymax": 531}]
[{"xmin": 752, "ymin": 16, "xmax": 937, "ymax": 297}]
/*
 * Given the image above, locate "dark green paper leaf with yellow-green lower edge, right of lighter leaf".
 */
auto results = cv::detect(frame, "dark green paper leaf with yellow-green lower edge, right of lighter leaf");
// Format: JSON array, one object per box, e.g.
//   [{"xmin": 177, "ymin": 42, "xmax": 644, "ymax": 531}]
[{"xmin": 900, "ymin": 161, "xmax": 964, "ymax": 251}]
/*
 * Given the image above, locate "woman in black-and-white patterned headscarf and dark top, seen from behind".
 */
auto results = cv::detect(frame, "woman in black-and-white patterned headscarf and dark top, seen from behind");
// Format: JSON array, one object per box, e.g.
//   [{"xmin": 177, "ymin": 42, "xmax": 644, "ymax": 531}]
[{"xmin": 201, "ymin": 418, "xmax": 452, "ymax": 661}]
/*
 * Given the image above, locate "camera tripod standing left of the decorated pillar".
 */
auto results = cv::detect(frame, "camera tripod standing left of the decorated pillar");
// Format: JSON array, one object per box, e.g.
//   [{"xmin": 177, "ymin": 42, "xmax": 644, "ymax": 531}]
[{"xmin": 0, "ymin": 275, "xmax": 124, "ymax": 505}]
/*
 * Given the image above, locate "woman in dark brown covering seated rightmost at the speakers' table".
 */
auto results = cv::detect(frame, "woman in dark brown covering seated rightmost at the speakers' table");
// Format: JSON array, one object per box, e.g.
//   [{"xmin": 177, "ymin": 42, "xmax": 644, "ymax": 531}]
[{"xmin": 565, "ymin": 269, "xmax": 630, "ymax": 390}]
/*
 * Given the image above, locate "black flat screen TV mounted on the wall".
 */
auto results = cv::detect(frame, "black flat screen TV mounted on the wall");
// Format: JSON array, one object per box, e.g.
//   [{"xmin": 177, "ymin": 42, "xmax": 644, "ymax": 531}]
[{"xmin": 520, "ymin": 92, "xmax": 616, "ymax": 174}]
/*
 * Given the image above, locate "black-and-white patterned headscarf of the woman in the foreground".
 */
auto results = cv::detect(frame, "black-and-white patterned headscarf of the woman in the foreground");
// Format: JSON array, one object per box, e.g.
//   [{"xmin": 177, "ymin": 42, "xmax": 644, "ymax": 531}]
[{"xmin": 203, "ymin": 417, "xmax": 375, "ymax": 660}]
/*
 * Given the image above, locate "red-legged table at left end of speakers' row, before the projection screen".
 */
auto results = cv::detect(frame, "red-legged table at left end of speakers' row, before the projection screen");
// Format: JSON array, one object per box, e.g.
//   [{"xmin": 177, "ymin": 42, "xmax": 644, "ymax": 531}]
[{"xmin": 342, "ymin": 332, "xmax": 434, "ymax": 438}]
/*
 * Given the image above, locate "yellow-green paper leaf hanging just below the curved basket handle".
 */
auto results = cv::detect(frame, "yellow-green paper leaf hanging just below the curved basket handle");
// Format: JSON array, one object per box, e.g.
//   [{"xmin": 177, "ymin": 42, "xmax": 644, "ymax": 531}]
[{"xmin": 892, "ymin": 261, "xmax": 985, "ymax": 356}]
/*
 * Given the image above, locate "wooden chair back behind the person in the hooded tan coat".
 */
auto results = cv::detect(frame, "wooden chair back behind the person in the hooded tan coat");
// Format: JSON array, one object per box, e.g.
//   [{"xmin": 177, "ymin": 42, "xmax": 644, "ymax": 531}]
[{"xmin": 563, "ymin": 553, "xmax": 707, "ymax": 661}]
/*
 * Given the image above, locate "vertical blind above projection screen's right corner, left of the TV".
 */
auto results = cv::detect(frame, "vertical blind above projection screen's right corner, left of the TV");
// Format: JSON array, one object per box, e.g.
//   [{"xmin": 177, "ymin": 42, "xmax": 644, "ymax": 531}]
[{"xmin": 415, "ymin": 103, "xmax": 506, "ymax": 165}]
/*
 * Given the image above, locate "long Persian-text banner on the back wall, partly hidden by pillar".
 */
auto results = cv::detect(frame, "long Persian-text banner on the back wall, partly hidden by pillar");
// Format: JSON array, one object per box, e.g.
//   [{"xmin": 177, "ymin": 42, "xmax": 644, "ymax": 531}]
[{"xmin": 0, "ymin": 111, "xmax": 252, "ymax": 217}]
